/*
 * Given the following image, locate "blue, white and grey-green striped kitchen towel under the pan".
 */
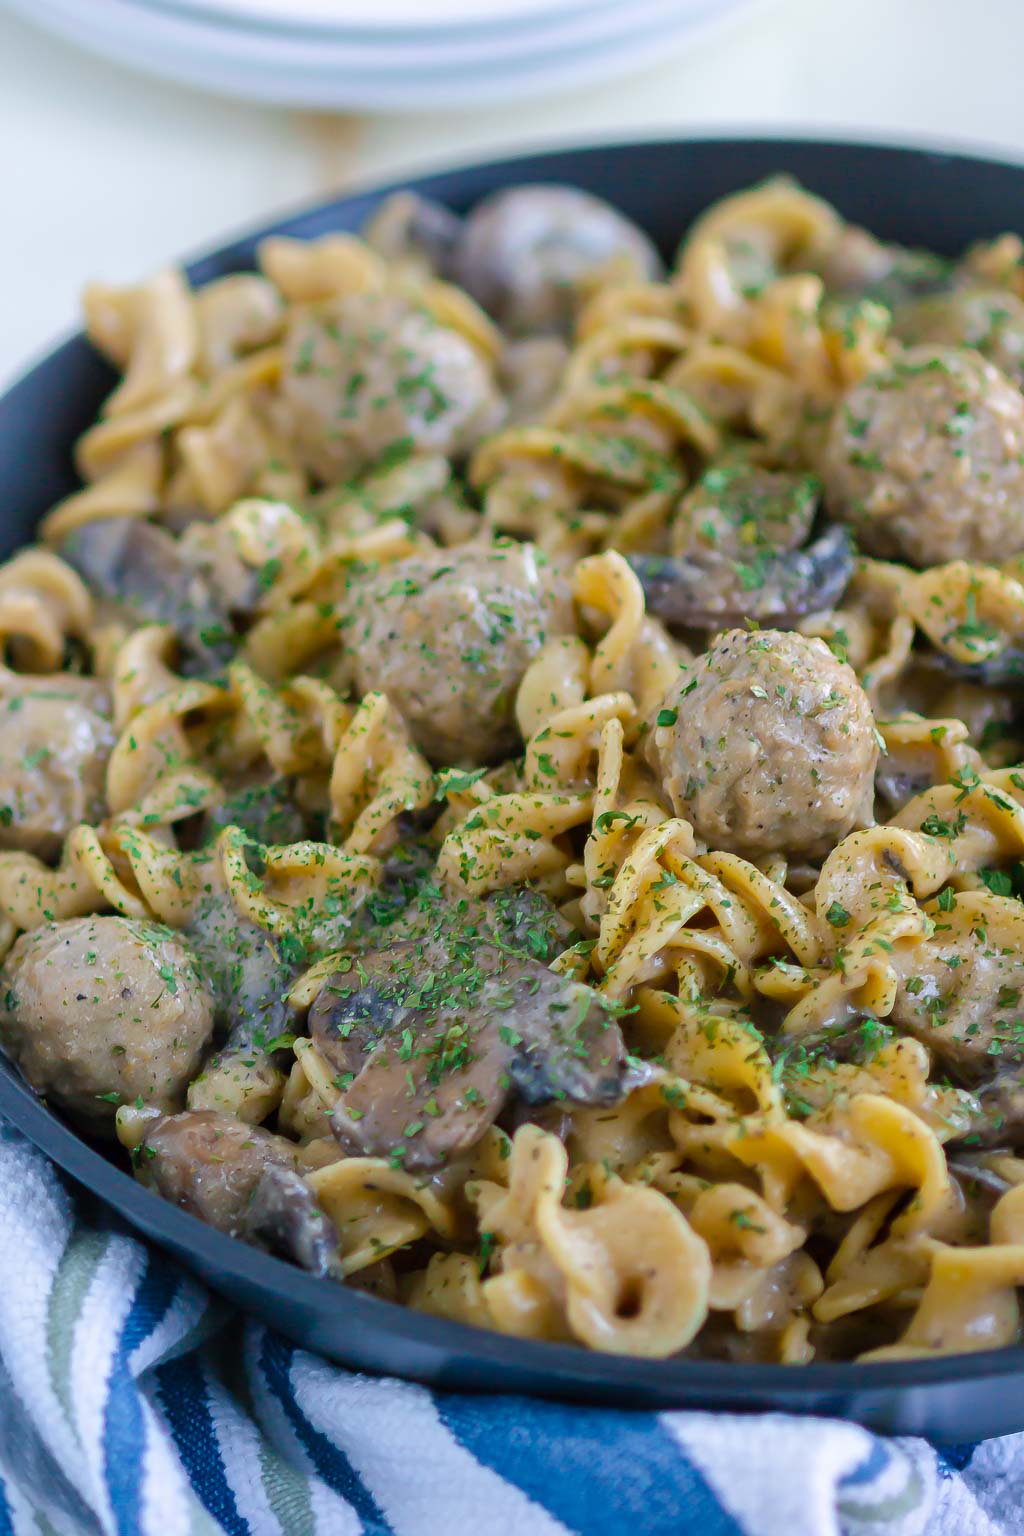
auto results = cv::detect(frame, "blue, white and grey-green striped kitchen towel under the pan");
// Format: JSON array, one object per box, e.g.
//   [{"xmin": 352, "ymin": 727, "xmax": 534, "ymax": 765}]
[{"xmin": 0, "ymin": 1126, "xmax": 1024, "ymax": 1536}]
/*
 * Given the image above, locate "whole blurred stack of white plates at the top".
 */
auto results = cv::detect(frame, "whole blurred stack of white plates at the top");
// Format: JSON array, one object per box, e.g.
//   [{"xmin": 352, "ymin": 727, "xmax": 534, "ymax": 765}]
[{"xmin": 0, "ymin": 0, "xmax": 751, "ymax": 112}]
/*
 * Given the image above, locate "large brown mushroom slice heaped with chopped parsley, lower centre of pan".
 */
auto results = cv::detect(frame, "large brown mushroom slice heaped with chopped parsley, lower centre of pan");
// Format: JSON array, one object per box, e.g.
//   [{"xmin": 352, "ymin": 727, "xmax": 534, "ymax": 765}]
[{"xmin": 309, "ymin": 938, "xmax": 626, "ymax": 1167}]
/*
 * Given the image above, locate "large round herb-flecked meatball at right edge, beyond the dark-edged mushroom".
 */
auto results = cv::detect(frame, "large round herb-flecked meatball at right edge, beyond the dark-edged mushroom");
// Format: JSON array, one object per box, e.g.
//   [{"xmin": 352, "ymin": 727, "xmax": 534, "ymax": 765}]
[{"xmin": 824, "ymin": 347, "xmax": 1024, "ymax": 565}]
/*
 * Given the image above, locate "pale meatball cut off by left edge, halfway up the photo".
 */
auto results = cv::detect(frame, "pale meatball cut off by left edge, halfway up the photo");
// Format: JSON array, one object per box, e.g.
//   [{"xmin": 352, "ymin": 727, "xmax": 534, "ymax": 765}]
[{"xmin": 0, "ymin": 674, "xmax": 115, "ymax": 859}]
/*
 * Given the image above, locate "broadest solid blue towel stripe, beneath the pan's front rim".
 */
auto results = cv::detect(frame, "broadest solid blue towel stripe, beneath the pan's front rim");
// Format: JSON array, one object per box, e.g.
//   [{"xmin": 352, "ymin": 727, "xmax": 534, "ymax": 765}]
[{"xmin": 434, "ymin": 1396, "xmax": 743, "ymax": 1536}]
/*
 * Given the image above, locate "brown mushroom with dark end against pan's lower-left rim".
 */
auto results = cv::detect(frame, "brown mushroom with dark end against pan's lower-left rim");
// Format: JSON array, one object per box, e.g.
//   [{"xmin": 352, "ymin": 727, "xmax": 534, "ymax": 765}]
[{"xmin": 134, "ymin": 1109, "xmax": 338, "ymax": 1275}]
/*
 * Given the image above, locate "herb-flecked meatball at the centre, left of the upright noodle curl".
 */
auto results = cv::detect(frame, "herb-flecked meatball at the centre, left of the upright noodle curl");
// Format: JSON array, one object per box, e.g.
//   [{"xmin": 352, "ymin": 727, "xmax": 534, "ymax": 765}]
[{"xmin": 344, "ymin": 544, "xmax": 571, "ymax": 765}]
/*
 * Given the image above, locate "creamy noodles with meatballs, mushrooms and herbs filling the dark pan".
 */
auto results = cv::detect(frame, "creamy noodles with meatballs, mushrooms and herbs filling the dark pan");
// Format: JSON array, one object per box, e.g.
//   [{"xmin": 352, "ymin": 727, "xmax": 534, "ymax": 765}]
[{"xmin": 0, "ymin": 180, "xmax": 1024, "ymax": 1364}]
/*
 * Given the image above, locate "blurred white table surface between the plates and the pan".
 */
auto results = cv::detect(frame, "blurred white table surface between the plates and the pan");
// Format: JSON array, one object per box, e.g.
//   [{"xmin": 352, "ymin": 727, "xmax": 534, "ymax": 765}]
[{"xmin": 0, "ymin": 0, "xmax": 1024, "ymax": 393}]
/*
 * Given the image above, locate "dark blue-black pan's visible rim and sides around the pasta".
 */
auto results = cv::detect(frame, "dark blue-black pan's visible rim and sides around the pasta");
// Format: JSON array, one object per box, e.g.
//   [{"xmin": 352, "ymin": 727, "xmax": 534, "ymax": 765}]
[{"xmin": 0, "ymin": 140, "xmax": 1024, "ymax": 1441}]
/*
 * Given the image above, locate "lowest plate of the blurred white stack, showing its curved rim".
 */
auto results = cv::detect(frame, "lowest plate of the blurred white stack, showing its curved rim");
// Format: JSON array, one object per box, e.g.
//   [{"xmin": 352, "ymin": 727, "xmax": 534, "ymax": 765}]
[{"xmin": 6, "ymin": 0, "xmax": 751, "ymax": 112}]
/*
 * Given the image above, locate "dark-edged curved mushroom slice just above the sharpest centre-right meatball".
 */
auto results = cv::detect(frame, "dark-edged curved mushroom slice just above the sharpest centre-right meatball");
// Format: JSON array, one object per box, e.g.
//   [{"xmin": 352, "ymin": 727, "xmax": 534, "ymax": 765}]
[{"xmin": 629, "ymin": 527, "xmax": 855, "ymax": 630}]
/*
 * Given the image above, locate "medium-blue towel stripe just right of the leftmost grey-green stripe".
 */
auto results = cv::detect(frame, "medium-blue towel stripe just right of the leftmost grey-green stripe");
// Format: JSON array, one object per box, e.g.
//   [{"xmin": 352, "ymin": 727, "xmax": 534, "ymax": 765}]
[{"xmin": 103, "ymin": 1253, "xmax": 178, "ymax": 1536}]
